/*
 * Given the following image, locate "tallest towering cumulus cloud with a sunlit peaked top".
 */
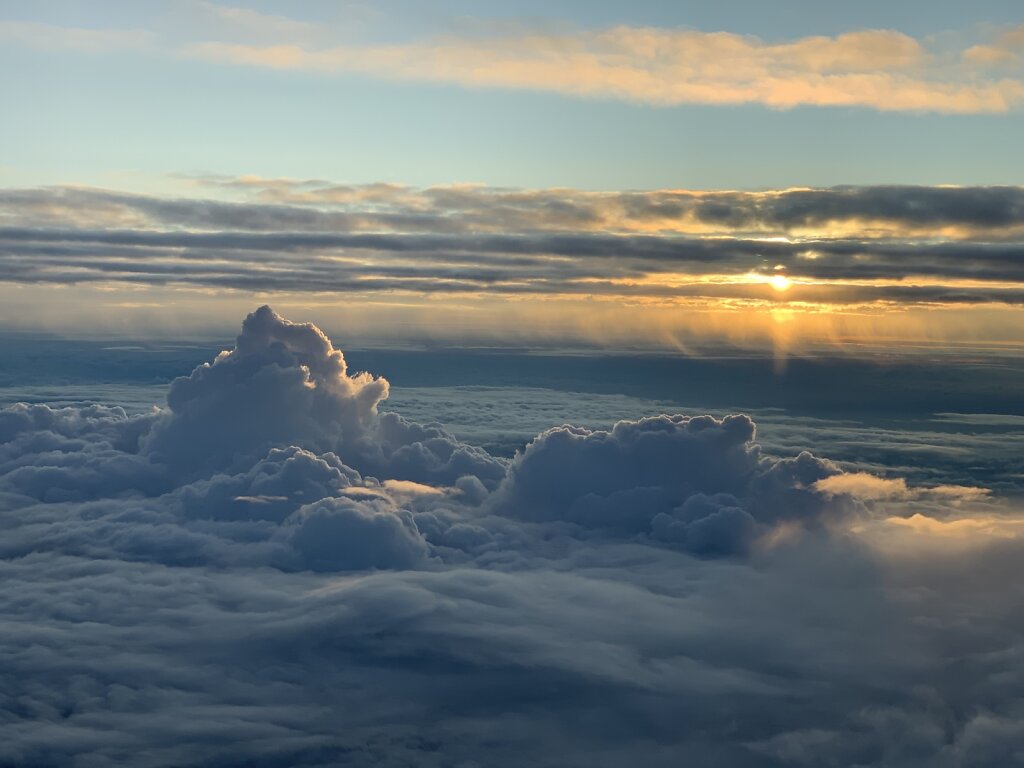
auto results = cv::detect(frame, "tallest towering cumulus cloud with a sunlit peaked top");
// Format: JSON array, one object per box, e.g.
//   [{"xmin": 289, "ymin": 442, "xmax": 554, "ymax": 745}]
[{"xmin": 141, "ymin": 306, "xmax": 504, "ymax": 483}]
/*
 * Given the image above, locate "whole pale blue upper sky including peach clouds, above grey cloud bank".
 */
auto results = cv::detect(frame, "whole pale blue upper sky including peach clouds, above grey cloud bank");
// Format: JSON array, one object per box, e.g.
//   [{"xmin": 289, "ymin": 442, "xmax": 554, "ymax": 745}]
[{"xmin": 6, "ymin": 0, "xmax": 1022, "ymax": 191}]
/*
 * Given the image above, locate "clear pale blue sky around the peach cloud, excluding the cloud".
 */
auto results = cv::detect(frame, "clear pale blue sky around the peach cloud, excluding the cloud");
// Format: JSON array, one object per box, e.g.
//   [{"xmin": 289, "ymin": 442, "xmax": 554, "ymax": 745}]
[{"xmin": 0, "ymin": 2, "xmax": 1024, "ymax": 191}]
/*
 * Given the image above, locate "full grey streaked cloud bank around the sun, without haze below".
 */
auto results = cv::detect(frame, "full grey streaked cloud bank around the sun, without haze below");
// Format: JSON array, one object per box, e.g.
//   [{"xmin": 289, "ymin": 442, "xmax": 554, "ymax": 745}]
[{"xmin": 0, "ymin": 184, "xmax": 1024, "ymax": 304}]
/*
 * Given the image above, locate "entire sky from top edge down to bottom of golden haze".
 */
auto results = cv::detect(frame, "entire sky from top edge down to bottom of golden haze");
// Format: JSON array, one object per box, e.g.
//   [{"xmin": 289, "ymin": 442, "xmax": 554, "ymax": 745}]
[{"xmin": 0, "ymin": 0, "xmax": 1024, "ymax": 354}]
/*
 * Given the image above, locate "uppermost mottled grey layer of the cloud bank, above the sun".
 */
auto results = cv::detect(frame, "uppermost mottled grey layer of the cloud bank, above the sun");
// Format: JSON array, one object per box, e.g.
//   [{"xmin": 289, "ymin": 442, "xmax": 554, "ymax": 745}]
[{"xmin": 12, "ymin": 183, "xmax": 1024, "ymax": 233}]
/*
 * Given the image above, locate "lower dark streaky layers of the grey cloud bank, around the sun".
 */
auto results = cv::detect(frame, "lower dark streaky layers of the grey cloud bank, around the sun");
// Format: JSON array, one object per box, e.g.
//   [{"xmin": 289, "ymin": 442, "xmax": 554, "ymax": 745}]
[{"xmin": 6, "ymin": 229, "xmax": 1024, "ymax": 304}]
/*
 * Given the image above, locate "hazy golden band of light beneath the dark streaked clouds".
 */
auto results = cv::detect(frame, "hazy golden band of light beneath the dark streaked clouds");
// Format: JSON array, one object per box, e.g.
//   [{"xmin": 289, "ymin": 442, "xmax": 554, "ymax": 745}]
[{"xmin": 0, "ymin": 284, "xmax": 1024, "ymax": 358}]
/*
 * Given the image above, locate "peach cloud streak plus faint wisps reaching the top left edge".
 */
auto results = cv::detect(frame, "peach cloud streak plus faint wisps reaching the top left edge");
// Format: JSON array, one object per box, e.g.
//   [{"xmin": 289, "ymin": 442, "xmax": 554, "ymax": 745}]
[{"xmin": 0, "ymin": 7, "xmax": 1024, "ymax": 114}]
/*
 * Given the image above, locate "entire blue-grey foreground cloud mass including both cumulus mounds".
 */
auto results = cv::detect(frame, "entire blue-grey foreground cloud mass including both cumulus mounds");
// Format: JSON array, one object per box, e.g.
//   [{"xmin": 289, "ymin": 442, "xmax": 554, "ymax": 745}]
[{"xmin": 0, "ymin": 307, "xmax": 1024, "ymax": 767}]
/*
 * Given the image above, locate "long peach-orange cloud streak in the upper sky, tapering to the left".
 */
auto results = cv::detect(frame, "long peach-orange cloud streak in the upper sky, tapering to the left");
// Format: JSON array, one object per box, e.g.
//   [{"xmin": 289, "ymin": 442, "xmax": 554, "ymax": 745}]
[{"xmin": 183, "ymin": 26, "xmax": 1024, "ymax": 113}]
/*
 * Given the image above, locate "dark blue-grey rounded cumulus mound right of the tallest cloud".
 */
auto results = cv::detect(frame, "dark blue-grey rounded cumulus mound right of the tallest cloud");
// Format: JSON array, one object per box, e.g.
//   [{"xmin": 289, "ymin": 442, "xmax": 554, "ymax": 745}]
[{"xmin": 494, "ymin": 416, "xmax": 848, "ymax": 554}]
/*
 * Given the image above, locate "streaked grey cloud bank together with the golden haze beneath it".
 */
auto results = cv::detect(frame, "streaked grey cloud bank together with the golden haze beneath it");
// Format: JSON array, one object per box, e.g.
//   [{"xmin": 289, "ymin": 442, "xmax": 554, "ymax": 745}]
[{"xmin": 0, "ymin": 177, "xmax": 1024, "ymax": 358}]
